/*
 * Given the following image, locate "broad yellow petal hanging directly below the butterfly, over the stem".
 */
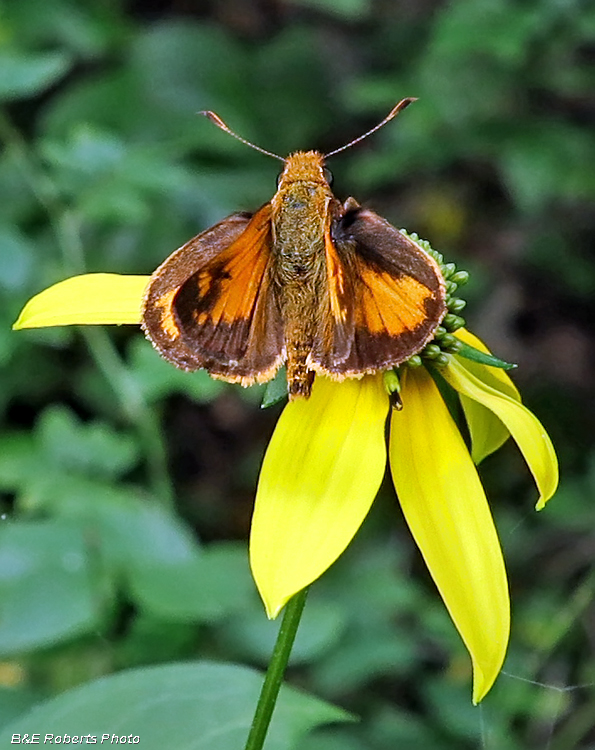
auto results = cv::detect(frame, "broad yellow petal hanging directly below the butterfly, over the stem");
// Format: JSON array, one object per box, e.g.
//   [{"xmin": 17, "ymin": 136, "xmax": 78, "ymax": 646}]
[{"xmin": 250, "ymin": 376, "xmax": 388, "ymax": 617}]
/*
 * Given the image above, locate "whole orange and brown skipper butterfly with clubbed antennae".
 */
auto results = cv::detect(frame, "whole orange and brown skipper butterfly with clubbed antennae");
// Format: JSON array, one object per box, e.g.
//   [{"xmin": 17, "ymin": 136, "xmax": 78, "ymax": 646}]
[{"xmin": 142, "ymin": 99, "xmax": 446, "ymax": 399}]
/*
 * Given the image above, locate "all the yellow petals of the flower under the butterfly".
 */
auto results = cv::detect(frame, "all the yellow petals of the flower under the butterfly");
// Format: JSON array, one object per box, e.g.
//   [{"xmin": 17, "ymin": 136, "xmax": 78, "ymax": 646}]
[{"xmin": 15, "ymin": 274, "xmax": 558, "ymax": 703}]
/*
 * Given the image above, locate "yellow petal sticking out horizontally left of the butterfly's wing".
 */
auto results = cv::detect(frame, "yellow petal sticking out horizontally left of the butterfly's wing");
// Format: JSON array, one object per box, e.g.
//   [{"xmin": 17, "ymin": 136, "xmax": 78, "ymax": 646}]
[{"xmin": 13, "ymin": 273, "xmax": 151, "ymax": 329}]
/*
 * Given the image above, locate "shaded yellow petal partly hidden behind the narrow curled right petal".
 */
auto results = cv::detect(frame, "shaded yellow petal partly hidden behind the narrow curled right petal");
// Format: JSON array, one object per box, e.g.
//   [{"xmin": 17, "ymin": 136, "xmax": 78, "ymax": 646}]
[{"xmin": 456, "ymin": 328, "xmax": 521, "ymax": 464}]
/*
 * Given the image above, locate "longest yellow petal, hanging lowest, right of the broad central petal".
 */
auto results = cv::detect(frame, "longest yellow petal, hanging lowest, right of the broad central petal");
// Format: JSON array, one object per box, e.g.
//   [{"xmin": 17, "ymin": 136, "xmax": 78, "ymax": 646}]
[{"xmin": 389, "ymin": 367, "xmax": 510, "ymax": 703}]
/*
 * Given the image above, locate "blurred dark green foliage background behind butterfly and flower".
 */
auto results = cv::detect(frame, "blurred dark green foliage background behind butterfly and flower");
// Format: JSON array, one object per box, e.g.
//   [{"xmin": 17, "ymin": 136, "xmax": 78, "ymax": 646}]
[{"xmin": 0, "ymin": 0, "xmax": 595, "ymax": 750}]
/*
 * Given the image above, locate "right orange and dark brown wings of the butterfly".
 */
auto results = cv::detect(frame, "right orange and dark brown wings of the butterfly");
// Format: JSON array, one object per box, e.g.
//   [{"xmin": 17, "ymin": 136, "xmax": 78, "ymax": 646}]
[{"xmin": 312, "ymin": 201, "xmax": 446, "ymax": 377}]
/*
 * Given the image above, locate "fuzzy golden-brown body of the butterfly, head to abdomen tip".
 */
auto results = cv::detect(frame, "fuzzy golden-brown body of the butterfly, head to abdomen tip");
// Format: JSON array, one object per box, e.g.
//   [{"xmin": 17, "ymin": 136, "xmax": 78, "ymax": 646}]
[{"xmin": 271, "ymin": 151, "xmax": 334, "ymax": 396}]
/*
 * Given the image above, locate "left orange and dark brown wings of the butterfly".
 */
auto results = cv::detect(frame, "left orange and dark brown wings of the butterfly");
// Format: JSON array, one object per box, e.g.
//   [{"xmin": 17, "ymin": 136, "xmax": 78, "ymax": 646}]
[{"xmin": 143, "ymin": 204, "xmax": 284, "ymax": 385}]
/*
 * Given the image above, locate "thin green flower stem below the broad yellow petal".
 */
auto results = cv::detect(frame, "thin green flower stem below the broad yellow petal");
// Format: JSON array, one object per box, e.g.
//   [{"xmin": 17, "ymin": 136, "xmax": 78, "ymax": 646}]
[{"xmin": 244, "ymin": 588, "xmax": 308, "ymax": 750}]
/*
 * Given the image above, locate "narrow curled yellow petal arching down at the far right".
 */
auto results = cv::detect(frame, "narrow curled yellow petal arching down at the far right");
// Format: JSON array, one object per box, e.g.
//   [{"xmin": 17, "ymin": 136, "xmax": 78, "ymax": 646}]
[{"xmin": 441, "ymin": 358, "xmax": 558, "ymax": 510}]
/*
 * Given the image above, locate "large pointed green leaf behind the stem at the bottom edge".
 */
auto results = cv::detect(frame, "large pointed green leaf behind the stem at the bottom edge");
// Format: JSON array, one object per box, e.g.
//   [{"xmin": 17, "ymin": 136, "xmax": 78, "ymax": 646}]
[{"xmin": 0, "ymin": 662, "xmax": 350, "ymax": 750}]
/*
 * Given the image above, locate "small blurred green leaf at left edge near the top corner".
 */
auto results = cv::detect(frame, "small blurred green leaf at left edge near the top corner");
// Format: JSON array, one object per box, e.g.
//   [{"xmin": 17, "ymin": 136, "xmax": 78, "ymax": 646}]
[{"xmin": 0, "ymin": 50, "xmax": 72, "ymax": 100}]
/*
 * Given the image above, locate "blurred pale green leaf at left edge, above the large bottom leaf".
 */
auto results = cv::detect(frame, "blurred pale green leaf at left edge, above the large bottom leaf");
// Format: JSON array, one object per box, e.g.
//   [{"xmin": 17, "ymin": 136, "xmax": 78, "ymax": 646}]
[{"xmin": 0, "ymin": 521, "xmax": 99, "ymax": 655}]
